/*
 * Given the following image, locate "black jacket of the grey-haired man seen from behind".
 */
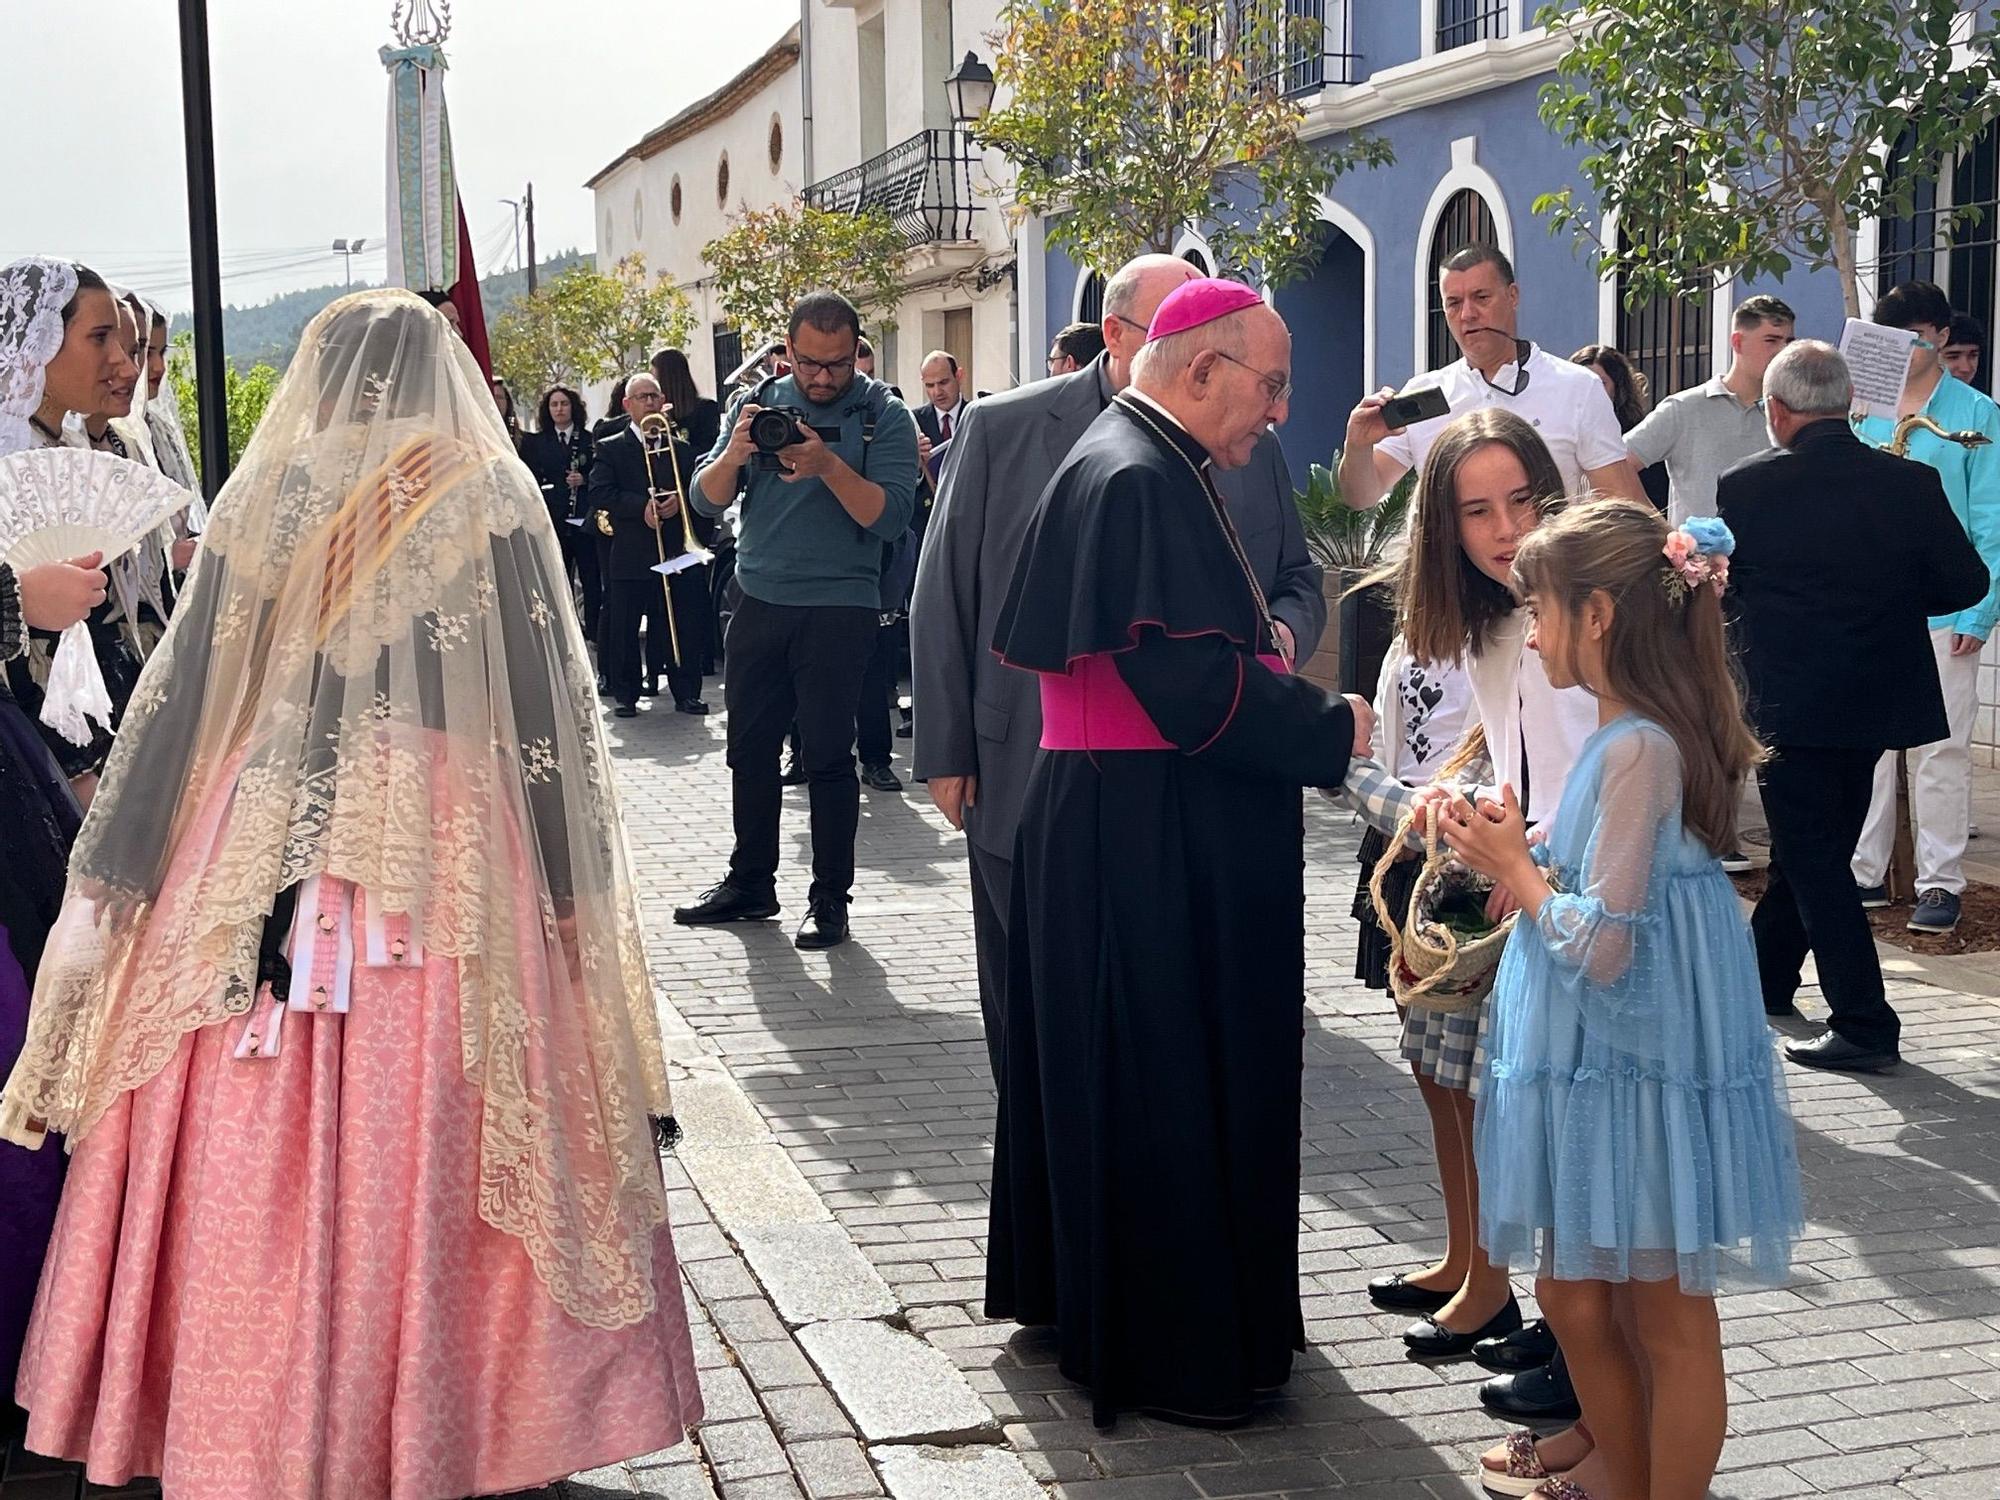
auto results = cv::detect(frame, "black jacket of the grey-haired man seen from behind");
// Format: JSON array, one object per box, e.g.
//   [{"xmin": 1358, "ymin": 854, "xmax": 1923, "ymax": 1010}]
[{"xmin": 1716, "ymin": 418, "xmax": 1992, "ymax": 750}]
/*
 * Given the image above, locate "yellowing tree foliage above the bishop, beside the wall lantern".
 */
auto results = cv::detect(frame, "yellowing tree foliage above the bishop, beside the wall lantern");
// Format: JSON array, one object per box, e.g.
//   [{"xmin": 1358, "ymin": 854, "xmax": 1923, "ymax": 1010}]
[{"xmin": 978, "ymin": 0, "xmax": 1394, "ymax": 286}]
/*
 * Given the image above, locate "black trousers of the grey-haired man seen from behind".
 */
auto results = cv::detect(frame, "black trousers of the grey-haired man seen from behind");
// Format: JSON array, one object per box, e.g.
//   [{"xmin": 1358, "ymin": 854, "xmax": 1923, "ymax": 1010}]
[{"xmin": 1750, "ymin": 746, "xmax": 1902, "ymax": 1052}]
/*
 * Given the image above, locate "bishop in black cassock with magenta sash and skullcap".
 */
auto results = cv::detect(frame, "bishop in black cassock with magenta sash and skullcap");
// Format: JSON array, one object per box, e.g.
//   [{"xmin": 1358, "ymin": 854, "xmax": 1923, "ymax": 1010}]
[{"xmin": 986, "ymin": 280, "xmax": 1370, "ymax": 1424}]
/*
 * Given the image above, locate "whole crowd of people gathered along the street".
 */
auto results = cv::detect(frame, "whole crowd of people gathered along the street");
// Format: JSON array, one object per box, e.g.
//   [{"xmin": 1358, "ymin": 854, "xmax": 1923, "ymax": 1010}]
[{"xmin": 0, "ymin": 220, "xmax": 2000, "ymax": 1500}]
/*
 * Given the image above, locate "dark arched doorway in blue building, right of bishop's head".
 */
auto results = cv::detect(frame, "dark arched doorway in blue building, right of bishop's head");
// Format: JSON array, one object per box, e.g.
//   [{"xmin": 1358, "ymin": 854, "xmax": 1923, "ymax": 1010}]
[{"xmin": 1272, "ymin": 220, "xmax": 1368, "ymax": 488}]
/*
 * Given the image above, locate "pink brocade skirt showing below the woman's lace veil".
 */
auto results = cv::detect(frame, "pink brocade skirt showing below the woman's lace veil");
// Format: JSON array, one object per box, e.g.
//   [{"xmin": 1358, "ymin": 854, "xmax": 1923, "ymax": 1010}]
[{"xmin": 18, "ymin": 788, "xmax": 702, "ymax": 1500}]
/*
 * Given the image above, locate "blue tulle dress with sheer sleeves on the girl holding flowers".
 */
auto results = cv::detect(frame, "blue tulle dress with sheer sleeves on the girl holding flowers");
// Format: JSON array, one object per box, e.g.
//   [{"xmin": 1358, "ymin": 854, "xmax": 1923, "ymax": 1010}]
[{"xmin": 1474, "ymin": 716, "xmax": 1804, "ymax": 1292}]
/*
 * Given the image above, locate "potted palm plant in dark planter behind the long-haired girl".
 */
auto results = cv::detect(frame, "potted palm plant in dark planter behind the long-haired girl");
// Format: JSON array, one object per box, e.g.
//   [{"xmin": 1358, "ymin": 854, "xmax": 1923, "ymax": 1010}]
[{"xmin": 1292, "ymin": 454, "xmax": 1416, "ymax": 696}]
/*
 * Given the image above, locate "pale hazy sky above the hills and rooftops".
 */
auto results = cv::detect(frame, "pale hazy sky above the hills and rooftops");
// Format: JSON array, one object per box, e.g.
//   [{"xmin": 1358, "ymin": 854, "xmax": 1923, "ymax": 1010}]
[{"xmin": 0, "ymin": 0, "xmax": 798, "ymax": 312}]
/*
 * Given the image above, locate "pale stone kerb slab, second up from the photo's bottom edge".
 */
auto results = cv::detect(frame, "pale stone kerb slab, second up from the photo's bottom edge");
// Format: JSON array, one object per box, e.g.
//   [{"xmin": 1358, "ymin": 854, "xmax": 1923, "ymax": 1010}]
[{"xmin": 798, "ymin": 1320, "xmax": 1000, "ymax": 1442}]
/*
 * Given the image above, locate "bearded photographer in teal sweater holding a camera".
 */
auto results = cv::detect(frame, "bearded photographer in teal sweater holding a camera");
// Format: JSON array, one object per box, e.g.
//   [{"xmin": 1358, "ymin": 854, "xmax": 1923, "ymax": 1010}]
[{"xmin": 674, "ymin": 292, "xmax": 916, "ymax": 948}]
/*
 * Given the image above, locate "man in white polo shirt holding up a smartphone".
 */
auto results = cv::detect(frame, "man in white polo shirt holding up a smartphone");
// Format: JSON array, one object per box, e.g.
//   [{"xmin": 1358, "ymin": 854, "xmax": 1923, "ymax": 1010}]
[{"xmin": 1340, "ymin": 244, "xmax": 1646, "ymax": 510}]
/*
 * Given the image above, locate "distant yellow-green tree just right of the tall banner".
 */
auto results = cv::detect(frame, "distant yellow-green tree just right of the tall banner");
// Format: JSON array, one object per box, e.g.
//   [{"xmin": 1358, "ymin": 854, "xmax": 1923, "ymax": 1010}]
[{"xmin": 492, "ymin": 254, "xmax": 694, "ymax": 406}]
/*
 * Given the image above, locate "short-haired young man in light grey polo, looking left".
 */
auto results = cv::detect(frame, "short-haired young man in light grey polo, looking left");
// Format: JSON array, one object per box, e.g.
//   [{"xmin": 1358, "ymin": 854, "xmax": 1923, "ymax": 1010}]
[{"xmin": 1626, "ymin": 294, "xmax": 1798, "ymax": 526}]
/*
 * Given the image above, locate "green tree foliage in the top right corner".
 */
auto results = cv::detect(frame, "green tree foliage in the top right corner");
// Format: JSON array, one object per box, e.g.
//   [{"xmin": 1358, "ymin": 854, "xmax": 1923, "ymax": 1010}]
[{"xmin": 1534, "ymin": 0, "xmax": 1994, "ymax": 316}]
